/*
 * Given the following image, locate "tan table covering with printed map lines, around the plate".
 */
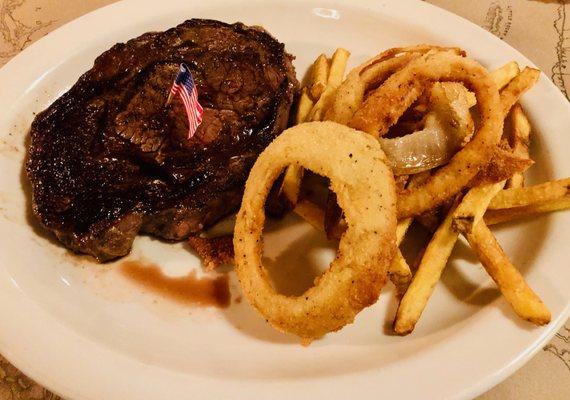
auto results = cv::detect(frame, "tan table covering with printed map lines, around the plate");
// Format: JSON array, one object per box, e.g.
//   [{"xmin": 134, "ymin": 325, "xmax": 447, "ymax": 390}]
[{"xmin": 0, "ymin": 0, "xmax": 570, "ymax": 400}]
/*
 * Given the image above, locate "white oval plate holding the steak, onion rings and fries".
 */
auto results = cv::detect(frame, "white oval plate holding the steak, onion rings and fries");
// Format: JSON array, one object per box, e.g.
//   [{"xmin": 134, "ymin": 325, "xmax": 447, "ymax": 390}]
[{"xmin": 0, "ymin": 0, "xmax": 570, "ymax": 400}]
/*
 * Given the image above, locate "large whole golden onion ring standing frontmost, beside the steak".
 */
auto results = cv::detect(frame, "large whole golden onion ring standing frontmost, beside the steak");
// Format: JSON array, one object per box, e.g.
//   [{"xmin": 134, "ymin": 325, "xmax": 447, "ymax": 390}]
[{"xmin": 234, "ymin": 122, "xmax": 396, "ymax": 341}]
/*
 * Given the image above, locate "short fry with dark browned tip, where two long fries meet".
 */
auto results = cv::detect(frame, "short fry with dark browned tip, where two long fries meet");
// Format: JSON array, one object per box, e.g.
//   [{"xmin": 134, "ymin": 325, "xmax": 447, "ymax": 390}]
[{"xmin": 452, "ymin": 181, "xmax": 505, "ymax": 234}]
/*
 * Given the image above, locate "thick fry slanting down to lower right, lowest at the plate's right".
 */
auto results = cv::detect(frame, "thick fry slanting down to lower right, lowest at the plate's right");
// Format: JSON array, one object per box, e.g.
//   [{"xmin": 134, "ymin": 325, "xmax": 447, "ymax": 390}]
[{"xmin": 466, "ymin": 222, "xmax": 550, "ymax": 325}]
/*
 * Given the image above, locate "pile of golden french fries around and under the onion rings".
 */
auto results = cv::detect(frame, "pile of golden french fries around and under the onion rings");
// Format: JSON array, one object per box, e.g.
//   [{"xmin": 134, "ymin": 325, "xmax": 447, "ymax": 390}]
[{"xmin": 281, "ymin": 49, "xmax": 570, "ymax": 335}]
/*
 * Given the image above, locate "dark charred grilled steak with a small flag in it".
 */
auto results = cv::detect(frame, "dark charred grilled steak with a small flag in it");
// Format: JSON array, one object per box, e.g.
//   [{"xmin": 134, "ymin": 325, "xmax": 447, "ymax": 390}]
[{"xmin": 27, "ymin": 19, "xmax": 298, "ymax": 262}]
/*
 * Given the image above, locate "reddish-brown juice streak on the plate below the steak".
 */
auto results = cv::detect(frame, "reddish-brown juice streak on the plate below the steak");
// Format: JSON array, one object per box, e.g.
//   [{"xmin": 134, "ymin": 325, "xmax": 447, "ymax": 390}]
[{"xmin": 121, "ymin": 261, "xmax": 231, "ymax": 308}]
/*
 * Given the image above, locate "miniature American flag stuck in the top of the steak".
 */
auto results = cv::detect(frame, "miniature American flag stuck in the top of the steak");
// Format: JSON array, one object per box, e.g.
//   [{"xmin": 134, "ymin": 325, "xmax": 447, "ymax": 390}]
[{"xmin": 166, "ymin": 63, "xmax": 204, "ymax": 139}]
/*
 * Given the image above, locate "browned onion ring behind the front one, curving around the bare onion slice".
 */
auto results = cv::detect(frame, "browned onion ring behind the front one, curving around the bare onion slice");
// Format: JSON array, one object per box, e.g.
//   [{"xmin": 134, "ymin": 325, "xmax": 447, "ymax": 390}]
[{"xmin": 349, "ymin": 52, "xmax": 503, "ymax": 218}]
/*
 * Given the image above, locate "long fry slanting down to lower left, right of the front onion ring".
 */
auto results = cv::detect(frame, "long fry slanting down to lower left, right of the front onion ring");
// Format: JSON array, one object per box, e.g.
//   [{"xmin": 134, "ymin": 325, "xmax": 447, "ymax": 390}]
[{"xmin": 394, "ymin": 199, "xmax": 458, "ymax": 335}]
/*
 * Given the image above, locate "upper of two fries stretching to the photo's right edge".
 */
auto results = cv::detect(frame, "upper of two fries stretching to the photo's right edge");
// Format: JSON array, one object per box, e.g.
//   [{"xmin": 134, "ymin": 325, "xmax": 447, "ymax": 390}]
[{"xmin": 489, "ymin": 178, "xmax": 570, "ymax": 210}]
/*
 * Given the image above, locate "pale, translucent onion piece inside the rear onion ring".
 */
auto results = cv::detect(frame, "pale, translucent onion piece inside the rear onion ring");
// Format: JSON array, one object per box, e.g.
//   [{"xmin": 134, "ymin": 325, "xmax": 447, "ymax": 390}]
[{"xmin": 380, "ymin": 82, "xmax": 474, "ymax": 175}]
